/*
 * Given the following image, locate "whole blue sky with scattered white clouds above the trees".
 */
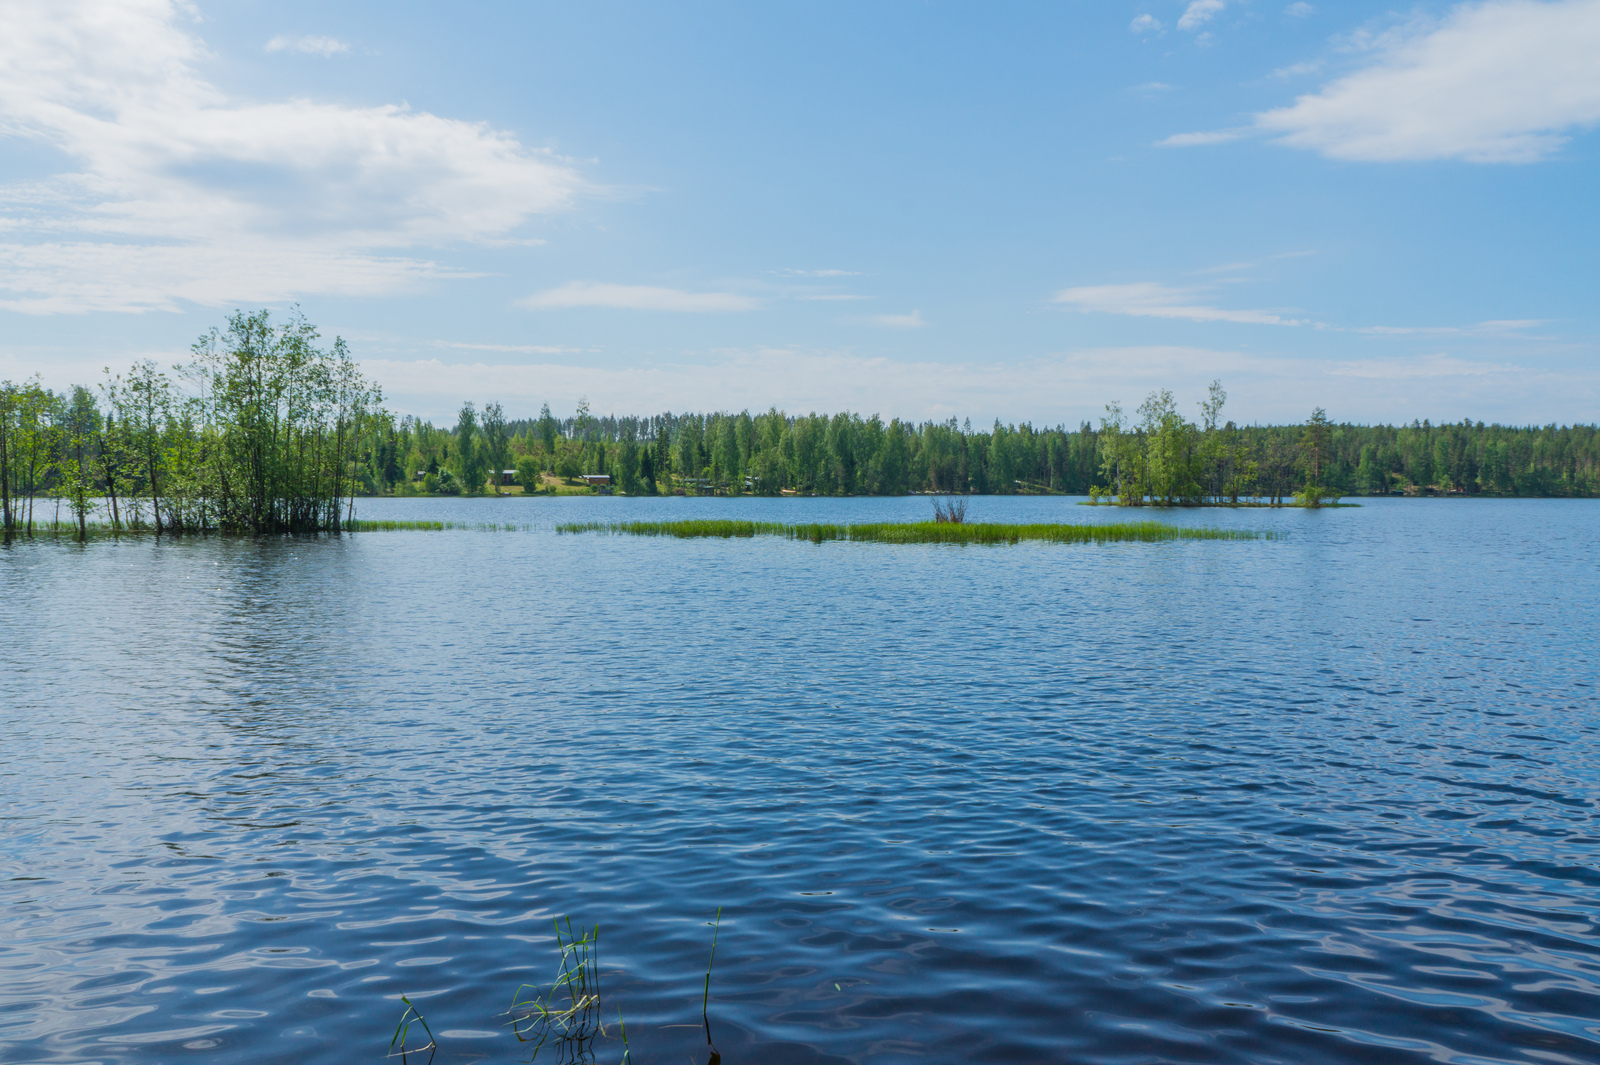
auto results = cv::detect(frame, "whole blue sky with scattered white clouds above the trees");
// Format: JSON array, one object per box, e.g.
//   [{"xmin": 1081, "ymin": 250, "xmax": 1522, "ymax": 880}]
[{"xmin": 0, "ymin": 0, "xmax": 1600, "ymax": 425}]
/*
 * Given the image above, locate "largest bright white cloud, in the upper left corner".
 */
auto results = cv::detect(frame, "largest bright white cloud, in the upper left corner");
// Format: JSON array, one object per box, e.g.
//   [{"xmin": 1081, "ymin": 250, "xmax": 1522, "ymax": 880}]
[{"xmin": 0, "ymin": 0, "xmax": 584, "ymax": 313}]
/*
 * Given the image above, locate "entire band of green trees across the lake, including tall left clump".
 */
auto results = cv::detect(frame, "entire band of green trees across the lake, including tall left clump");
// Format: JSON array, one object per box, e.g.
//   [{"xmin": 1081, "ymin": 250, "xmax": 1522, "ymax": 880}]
[{"xmin": 0, "ymin": 312, "xmax": 1600, "ymax": 533}]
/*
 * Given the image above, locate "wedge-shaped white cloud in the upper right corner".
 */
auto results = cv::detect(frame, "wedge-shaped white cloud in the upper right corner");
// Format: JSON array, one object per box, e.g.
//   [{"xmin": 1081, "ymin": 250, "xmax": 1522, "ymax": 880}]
[{"xmin": 1256, "ymin": 0, "xmax": 1600, "ymax": 163}]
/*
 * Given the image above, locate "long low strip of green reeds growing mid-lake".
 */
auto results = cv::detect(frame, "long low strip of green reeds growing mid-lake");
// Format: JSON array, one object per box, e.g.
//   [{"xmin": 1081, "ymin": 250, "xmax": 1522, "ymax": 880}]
[{"xmin": 555, "ymin": 521, "xmax": 1283, "ymax": 544}]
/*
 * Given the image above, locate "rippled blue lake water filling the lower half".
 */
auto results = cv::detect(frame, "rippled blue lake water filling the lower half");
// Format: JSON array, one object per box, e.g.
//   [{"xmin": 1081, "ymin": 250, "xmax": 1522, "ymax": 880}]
[{"xmin": 0, "ymin": 497, "xmax": 1600, "ymax": 1065}]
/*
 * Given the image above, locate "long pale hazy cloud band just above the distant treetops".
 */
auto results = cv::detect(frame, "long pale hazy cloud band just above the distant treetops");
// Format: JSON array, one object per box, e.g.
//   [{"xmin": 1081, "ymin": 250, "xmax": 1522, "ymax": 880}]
[{"xmin": 344, "ymin": 345, "xmax": 1600, "ymax": 425}]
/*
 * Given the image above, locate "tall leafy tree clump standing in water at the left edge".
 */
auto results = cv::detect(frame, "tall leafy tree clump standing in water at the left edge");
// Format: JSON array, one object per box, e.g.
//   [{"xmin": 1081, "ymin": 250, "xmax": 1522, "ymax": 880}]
[{"xmin": 0, "ymin": 312, "xmax": 380, "ymax": 536}]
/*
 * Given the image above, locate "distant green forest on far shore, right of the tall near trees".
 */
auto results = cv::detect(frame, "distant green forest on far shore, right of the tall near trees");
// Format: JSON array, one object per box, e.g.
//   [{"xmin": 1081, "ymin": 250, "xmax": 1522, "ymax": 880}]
[{"xmin": 380, "ymin": 384, "xmax": 1600, "ymax": 505}]
